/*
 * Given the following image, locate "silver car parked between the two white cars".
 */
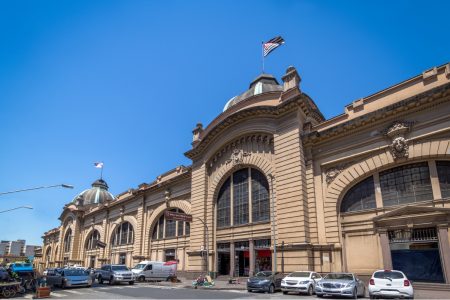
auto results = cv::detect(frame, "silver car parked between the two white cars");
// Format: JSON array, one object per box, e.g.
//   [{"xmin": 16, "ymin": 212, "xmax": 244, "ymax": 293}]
[{"xmin": 315, "ymin": 273, "xmax": 366, "ymax": 299}]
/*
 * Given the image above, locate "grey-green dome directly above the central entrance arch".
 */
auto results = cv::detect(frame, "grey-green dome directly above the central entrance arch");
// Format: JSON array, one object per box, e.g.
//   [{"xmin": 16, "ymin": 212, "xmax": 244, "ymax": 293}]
[{"xmin": 223, "ymin": 73, "xmax": 283, "ymax": 111}]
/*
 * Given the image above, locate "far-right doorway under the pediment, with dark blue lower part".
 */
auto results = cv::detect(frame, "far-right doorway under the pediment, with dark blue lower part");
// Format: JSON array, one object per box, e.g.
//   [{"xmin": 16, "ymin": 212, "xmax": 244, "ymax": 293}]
[{"xmin": 388, "ymin": 228, "xmax": 445, "ymax": 283}]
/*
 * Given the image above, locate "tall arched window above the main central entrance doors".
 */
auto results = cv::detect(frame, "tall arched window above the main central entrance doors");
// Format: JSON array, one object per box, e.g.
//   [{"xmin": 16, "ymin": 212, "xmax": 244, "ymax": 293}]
[{"xmin": 217, "ymin": 168, "xmax": 270, "ymax": 228}]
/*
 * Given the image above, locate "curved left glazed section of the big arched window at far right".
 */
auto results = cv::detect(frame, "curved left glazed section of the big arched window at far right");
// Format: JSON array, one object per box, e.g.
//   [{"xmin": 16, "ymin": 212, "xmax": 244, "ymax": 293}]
[{"xmin": 341, "ymin": 176, "xmax": 376, "ymax": 212}]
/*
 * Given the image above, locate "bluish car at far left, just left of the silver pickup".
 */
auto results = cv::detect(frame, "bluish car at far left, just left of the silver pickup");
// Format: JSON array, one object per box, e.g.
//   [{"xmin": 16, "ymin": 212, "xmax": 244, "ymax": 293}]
[{"xmin": 46, "ymin": 268, "xmax": 93, "ymax": 288}]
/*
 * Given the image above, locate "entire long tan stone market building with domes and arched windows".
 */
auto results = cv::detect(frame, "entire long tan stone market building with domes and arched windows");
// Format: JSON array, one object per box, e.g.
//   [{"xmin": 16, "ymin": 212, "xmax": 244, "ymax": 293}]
[{"xmin": 37, "ymin": 64, "xmax": 450, "ymax": 283}]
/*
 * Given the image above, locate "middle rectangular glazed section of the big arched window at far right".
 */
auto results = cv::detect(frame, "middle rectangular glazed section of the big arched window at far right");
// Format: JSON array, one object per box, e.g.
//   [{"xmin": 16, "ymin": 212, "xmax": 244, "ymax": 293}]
[{"xmin": 380, "ymin": 162, "xmax": 433, "ymax": 206}]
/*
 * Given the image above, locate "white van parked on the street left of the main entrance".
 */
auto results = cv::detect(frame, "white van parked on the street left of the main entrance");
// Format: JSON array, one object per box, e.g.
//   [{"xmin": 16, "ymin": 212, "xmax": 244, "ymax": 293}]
[{"xmin": 131, "ymin": 260, "xmax": 177, "ymax": 281}]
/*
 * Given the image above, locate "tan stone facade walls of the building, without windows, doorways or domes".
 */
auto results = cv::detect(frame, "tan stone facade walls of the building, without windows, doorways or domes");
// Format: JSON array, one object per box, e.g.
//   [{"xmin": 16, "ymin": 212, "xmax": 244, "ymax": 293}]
[{"xmin": 43, "ymin": 65, "xmax": 450, "ymax": 282}]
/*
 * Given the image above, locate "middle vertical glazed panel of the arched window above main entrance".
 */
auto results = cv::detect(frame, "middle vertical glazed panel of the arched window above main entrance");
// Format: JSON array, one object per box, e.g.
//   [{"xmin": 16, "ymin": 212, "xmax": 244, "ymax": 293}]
[{"xmin": 233, "ymin": 169, "xmax": 249, "ymax": 225}]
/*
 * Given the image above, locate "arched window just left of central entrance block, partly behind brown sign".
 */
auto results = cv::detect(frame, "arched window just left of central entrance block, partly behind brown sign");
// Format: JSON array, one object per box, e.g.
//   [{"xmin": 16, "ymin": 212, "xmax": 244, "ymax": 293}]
[{"xmin": 152, "ymin": 208, "xmax": 190, "ymax": 240}]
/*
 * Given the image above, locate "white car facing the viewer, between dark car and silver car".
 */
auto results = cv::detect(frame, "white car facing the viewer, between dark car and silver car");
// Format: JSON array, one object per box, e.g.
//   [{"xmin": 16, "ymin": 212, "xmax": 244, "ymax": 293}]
[{"xmin": 281, "ymin": 271, "xmax": 322, "ymax": 296}]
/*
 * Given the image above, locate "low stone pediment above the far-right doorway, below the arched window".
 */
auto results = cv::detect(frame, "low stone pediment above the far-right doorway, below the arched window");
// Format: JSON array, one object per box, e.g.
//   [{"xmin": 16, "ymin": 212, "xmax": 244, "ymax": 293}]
[{"xmin": 372, "ymin": 205, "xmax": 450, "ymax": 222}]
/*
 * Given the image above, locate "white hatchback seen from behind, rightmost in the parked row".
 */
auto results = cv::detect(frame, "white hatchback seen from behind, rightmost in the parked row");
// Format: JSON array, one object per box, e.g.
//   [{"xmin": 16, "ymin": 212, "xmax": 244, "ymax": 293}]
[{"xmin": 369, "ymin": 270, "xmax": 414, "ymax": 299}]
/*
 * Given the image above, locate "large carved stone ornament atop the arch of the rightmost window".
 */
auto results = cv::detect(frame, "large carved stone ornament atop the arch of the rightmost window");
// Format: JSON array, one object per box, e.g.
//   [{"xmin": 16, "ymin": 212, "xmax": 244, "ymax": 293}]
[{"xmin": 385, "ymin": 121, "xmax": 413, "ymax": 159}]
